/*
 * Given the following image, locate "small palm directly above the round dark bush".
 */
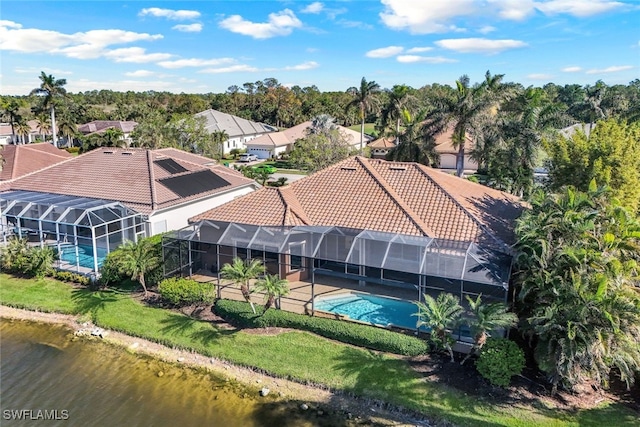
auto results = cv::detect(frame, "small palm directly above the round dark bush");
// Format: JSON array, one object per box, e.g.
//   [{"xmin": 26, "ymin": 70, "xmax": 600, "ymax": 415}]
[{"xmin": 460, "ymin": 295, "xmax": 518, "ymax": 365}]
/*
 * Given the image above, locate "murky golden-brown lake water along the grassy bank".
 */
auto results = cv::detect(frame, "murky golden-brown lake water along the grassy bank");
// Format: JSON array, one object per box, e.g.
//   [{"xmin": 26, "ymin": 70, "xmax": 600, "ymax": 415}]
[{"xmin": 0, "ymin": 319, "xmax": 348, "ymax": 427}]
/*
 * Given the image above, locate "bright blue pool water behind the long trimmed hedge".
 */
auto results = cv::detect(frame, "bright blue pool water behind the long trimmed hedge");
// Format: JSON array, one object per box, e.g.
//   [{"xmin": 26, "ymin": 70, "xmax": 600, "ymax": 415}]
[{"xmin": 315, "ymin": 292, "xmax": 418, "ymax": 329}]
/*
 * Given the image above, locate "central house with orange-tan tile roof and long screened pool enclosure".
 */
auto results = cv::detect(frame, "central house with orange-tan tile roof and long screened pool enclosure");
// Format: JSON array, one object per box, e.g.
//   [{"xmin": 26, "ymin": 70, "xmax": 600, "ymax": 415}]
[{"xmin": 163, "ymin": 156, "xmax": 523, "ymax": 334}]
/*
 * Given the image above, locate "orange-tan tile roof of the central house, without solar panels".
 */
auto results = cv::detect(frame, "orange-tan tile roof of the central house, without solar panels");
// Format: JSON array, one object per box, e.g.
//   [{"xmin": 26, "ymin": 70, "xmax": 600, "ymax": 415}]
[{"xmin": 190, "ymin": 156, "xmax": 523, "ymax": 249}]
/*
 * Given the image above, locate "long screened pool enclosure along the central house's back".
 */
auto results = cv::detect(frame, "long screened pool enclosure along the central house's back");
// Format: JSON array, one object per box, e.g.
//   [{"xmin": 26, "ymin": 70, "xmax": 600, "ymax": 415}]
[{"xmin": 163, "ymin": 220, "xmax": 512, "ymax": 310}]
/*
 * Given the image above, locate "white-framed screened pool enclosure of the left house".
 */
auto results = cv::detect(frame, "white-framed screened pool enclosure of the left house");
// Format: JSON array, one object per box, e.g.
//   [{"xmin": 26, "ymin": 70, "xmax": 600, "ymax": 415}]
[{"xmin": 0, "ymin": 191, "xmax": 145, "ymax": 274}]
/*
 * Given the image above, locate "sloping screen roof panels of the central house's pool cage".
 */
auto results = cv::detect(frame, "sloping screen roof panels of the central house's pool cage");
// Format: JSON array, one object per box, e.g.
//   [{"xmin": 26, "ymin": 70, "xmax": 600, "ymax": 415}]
[{"xmin": 165, "ymin": 220, "xmax": 512, "ymax": 289}]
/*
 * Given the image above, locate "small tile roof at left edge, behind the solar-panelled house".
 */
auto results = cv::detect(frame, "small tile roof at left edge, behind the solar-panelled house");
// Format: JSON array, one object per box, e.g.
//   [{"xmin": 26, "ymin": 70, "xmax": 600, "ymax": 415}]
[{"xmin": 0, "ymin": 142, "xmax": 73, "ymax": 181}]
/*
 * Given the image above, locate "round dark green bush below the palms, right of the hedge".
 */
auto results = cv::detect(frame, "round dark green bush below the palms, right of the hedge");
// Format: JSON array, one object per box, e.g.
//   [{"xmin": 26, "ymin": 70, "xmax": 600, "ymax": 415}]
[{"xmin": 476, "ymin": 338, "xmax": 525, "ymax": 387}]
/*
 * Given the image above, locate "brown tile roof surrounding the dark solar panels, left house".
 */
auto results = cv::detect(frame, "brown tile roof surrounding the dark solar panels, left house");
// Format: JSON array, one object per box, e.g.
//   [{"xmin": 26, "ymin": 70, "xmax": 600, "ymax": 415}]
[{"xmin": 0, "ymin": 147, "xmax": 256, "ymax": 214}]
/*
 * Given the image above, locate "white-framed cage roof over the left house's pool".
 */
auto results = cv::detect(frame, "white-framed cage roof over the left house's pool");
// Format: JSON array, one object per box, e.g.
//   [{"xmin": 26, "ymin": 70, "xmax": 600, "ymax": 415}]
[{"xmin": 0, "ymin": 191, "xmax": 141, "ymax": 228}]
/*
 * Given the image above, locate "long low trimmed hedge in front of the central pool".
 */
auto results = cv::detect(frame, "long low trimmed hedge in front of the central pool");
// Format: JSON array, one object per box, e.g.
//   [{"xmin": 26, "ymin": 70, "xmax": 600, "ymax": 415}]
[{"xmin": 214, "ymin": 299, "xmax": 429, "ymax": 356}]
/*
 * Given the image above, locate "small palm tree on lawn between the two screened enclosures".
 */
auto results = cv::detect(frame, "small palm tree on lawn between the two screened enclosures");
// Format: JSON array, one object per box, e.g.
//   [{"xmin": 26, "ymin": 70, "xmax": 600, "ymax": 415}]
[{"xmin": 116, "ymin": 239, "xmax": 160, "ymax": 297}]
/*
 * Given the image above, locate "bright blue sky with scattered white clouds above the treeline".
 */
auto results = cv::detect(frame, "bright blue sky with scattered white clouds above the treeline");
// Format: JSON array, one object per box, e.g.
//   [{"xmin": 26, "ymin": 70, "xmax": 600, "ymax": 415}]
[{"xmin": 0, "ymin": 0, "xmax": 640, "ymax": 95}]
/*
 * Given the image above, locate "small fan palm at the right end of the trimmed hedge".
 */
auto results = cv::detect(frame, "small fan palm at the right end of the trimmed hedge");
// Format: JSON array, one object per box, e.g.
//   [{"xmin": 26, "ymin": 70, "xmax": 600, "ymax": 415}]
[{"xmin": 415, "ymin": 292, "xmax": 464, "ymax": 362}]
